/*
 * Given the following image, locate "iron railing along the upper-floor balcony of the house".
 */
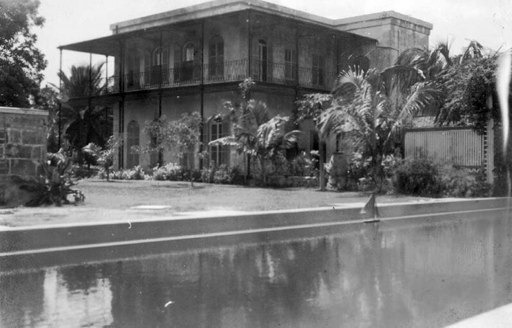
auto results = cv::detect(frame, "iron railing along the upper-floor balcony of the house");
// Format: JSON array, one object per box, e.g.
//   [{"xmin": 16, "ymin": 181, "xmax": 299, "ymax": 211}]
[{"xmin": 107, "ymin": 59, "xmax": 336, "ymax": 93}]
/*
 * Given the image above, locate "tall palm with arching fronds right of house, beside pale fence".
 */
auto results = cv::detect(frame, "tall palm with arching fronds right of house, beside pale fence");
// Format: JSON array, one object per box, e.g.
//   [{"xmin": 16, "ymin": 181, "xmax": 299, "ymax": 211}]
[{"xmin": 319, "ymin": 66, "xmax": 444, "ymax": 190}]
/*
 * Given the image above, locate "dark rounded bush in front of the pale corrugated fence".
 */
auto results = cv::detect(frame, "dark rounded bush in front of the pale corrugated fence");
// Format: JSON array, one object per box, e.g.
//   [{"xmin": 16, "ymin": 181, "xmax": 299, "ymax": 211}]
[{"xmin": 393, "ymin": 159, "xmax": 443, "ymax": 197}]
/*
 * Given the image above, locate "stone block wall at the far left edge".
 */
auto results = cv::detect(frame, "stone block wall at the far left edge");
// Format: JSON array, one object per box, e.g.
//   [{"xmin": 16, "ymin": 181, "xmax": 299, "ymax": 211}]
[{"xmin": 0, "ymin": 107, "xmax": 48, "ymax": 206}]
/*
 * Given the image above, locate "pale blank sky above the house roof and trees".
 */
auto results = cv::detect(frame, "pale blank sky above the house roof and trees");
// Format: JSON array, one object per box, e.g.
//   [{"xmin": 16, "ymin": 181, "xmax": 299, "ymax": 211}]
[{"xmin": 35, "ymin": 0, "xmax": 512, "ymax": 86}]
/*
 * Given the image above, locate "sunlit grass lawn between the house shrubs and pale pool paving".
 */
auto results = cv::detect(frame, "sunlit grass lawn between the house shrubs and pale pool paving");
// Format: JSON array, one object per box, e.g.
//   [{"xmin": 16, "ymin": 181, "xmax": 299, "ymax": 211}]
[{"xmin": 77, "ymin": 180, "xmax": 428, "ymax": 211}]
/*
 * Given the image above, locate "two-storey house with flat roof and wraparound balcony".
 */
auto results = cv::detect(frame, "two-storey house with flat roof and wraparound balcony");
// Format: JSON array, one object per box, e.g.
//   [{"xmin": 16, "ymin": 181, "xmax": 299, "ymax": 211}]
[{"xmin": 60, "ymin": 0, "xmax": 432, "ymax": 168}]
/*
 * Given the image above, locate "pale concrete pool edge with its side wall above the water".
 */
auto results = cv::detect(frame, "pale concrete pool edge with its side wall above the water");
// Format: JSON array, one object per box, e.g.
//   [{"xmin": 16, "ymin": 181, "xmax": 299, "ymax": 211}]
[{"xmin": 0, "ymin": 198, "xmax": 508, "ymax": 271}]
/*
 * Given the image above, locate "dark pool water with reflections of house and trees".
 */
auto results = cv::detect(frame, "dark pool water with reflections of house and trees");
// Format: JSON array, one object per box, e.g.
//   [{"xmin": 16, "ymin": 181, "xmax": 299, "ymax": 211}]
[{"xmin": 0, "ymin": 214, "xmax": 512, "ymax": 328}]
